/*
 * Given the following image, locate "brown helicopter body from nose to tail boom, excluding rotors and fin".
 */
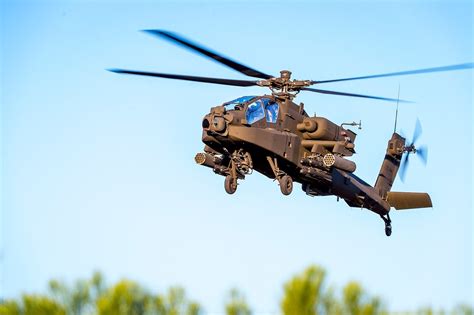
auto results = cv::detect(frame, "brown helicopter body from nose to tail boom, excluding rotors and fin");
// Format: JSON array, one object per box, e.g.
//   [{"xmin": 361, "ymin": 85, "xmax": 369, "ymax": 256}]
[{"xmin": 196, "ymin": 95, "xmax": 390, "ymax": 215}]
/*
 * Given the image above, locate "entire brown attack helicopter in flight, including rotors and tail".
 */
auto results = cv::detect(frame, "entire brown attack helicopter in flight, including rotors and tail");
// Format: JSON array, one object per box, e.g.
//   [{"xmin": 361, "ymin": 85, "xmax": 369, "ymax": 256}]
[{"xmin": 110, "ymin": 30, "xmax": 474, "ymax": 236}]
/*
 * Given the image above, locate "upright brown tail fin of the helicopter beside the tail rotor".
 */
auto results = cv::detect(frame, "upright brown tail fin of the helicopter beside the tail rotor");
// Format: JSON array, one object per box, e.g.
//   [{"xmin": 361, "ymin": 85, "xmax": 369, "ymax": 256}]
[{"xmin": 375, "ymin": 132, "xmax": 405, "ymax": 199}]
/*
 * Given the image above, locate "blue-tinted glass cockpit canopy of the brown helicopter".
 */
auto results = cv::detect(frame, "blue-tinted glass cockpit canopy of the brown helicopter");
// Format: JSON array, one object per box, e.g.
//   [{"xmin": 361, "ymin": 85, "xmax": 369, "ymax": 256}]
[{"xmin": 224, "ymin": 96, "xmax": 279, "ymax": 124}]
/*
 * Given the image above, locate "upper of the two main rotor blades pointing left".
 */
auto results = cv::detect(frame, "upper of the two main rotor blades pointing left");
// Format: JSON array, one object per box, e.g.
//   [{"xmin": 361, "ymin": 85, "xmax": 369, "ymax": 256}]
[{"xmin": 144, "ymin": 30, "xmax": 273, "ymax": 79}]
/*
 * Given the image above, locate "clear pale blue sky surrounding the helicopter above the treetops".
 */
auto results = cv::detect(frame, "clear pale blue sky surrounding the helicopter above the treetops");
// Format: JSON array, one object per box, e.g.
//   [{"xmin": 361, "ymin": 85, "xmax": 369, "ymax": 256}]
[{"xmin": 0, "ymin": 0, "xmax": 474, "ymax": 313}]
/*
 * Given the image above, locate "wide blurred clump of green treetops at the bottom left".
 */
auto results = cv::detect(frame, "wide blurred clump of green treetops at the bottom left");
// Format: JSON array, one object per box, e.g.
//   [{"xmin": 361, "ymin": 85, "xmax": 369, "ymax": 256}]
[{"xmin": 0, "ymin": 273, "xmax": 201, "ymax": 315}]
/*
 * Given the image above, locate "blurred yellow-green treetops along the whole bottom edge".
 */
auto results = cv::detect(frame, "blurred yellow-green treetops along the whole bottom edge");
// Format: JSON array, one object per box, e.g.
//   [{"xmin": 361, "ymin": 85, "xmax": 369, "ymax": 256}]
[{"xmin": 0, "ymin": 266, "xmax": 474, "ymax": 315}]
